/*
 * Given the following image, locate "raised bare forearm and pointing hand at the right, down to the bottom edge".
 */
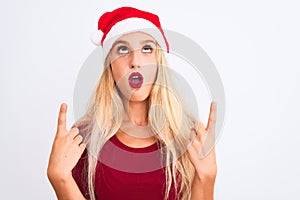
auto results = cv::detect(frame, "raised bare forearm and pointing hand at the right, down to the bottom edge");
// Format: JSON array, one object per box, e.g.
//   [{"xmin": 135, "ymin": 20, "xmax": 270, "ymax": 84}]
[{"xmin": 188, "ymin": 102, "xmax": 217, "ymax": 200}]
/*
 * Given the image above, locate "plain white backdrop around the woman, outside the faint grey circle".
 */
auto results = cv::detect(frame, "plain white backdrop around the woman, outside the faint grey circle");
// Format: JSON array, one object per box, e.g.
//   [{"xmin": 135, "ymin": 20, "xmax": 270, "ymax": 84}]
[{"xmin": 0, "ymin": 0, "xmax": 300, "ymax": 200}]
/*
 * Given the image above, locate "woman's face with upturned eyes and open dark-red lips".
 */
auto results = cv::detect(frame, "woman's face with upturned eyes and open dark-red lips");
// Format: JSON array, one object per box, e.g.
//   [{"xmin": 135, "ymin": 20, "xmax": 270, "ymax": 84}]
[{"xmin": 110, "ymin": 32, "xmax": 157, "ymax": 101}]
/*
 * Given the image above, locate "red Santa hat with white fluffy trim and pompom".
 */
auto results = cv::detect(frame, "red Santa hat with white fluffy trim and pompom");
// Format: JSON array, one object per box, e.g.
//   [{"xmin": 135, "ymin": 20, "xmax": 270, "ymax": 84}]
[{"xmin": 91, "ymin": 7, "xmax": 169, "ymax": 58}]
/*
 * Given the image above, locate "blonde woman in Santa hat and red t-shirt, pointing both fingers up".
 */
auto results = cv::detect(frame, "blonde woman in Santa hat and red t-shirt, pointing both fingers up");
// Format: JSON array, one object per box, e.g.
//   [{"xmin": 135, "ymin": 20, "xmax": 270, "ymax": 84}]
[{"xmin": 47, "ymin": 7, "xmax": 217, "ymax": 200}]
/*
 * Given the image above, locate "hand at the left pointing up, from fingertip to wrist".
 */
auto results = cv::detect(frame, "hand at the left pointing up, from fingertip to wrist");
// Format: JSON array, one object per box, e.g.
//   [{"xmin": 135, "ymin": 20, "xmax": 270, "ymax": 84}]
[{"xmin": 47, "ymin": 103, "xmax": 85, "ymax": 186}]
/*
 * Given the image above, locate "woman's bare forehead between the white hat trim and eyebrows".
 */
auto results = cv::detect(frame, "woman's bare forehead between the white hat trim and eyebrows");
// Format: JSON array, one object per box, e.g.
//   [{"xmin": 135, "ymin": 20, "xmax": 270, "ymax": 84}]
[{"xmin": 115, "ymin": 32, "xmax": 156, "ymax": 45}]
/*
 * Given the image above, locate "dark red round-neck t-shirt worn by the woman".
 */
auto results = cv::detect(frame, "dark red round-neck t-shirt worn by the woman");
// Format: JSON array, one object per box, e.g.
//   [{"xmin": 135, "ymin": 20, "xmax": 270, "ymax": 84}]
[{"xmin": 73, "ymin": 136, "xmax": 176, "ymax": 200}]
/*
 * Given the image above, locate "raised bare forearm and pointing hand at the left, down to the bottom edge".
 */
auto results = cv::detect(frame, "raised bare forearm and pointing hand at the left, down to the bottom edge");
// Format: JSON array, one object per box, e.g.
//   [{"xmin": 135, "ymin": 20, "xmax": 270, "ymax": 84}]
[{"xmin": 47, "ymin": 104, "xmax": 85, "ymax": 200}]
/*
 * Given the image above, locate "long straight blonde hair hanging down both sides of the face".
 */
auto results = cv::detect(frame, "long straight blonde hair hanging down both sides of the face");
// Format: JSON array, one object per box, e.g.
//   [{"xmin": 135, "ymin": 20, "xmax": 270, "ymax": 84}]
[{"xmin": 76, "ymin": 45, "xmax": 195, "ymax": 200}]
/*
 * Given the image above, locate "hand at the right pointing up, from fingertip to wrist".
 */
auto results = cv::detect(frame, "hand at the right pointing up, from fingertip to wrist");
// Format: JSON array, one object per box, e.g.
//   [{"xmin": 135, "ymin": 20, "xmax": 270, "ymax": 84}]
[{"xmin": 188, "ymin": 102, "xmax": 217, "ymax": 185}]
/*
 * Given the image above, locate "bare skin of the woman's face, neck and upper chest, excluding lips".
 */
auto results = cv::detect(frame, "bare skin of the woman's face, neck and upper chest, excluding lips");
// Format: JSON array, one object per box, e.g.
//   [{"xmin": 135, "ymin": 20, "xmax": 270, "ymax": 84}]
[{"xmin": 110, "ymin": 32, "xmax": 157, "ymax": 148}]
